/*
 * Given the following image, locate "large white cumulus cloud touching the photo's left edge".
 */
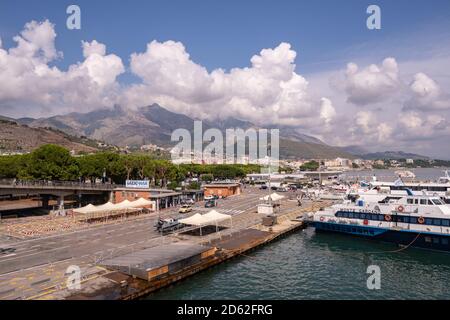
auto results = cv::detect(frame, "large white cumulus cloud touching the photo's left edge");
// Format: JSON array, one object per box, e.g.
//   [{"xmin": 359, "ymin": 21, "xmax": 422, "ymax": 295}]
[{"xmin": 0, "ymin": 20, "xmax": 125, "ymax": 116}]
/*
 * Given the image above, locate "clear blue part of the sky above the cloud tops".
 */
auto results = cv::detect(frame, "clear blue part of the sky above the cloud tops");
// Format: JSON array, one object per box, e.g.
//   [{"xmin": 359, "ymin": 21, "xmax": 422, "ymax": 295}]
[{"xmin": 0, "ymin": 0, "xmax": 450, "ymax": 73}]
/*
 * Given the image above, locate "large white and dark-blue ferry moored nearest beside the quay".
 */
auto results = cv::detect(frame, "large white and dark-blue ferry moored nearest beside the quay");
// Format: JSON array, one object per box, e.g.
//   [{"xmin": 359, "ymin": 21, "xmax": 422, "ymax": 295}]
[{"xmin": 313, "ymin": 190, "xmax": 450, "ymax": 251}]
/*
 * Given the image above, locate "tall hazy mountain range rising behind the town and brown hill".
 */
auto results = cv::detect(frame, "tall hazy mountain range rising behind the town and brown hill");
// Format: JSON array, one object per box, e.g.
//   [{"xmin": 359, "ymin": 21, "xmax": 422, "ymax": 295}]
[{"xmin": 0, "ymin": 104, "xmax": 426, "ymax": 159}]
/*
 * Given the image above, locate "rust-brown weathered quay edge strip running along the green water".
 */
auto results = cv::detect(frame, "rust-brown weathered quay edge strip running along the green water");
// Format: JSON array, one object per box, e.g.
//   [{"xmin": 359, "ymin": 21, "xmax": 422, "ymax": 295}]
[{"xmin": 60, "ymin": 203, "xmax": 327, "ymax": 300}]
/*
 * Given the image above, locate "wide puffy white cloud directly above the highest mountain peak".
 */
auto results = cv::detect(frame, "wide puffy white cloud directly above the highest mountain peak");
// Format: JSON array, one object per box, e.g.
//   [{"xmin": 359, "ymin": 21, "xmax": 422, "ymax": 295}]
[{"xmin": 123, "ymin": 41, "xmax": 328, "ymax": 125}]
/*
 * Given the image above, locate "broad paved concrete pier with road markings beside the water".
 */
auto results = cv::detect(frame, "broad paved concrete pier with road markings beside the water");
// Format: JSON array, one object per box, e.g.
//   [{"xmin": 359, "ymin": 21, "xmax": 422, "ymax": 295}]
[{"xmin": 0, "ymin": 188, "xmax": 329, "ymax": 299}]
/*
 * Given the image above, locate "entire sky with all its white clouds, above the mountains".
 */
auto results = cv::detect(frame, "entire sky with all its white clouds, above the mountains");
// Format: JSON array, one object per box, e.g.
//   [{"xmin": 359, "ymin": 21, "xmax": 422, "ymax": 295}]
[{"xmin": 0, "ymin": 0, "xmax": 450, "ymax": 158}]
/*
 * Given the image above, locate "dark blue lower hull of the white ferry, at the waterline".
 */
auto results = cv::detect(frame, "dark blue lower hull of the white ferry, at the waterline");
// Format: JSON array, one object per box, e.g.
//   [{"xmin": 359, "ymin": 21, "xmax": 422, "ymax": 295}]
[{"xmin": 312, "ymin": 221, "xmax": 450, "ymax": 252}]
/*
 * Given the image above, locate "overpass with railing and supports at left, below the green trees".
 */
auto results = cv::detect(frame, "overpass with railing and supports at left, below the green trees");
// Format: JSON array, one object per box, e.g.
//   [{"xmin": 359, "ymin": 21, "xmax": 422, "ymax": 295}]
[{"xmin": 0, "ymin": 179, "xmax": 123, "ymax": 209}]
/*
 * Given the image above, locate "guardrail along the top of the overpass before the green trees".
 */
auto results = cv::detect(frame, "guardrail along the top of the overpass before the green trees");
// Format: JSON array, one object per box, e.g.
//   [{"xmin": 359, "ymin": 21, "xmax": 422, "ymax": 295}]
[{"xmin": 0, "ymin": 179, "xmax": 123, "ymax": 190}]
